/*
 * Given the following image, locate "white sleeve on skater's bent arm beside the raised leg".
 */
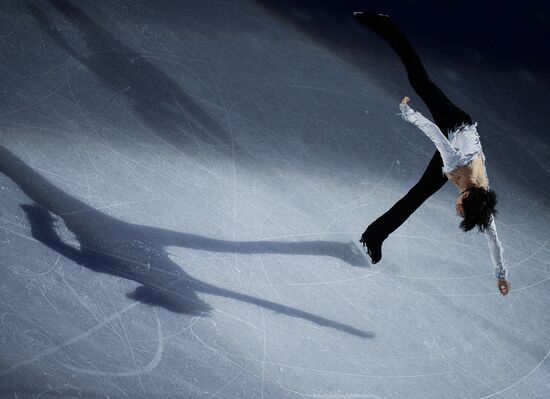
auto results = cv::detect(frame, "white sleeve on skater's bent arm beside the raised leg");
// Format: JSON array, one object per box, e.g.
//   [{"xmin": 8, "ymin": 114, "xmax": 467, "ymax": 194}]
[{"xmin": 399, "ymin": 103, "xmax": 463, "ymax": 172}]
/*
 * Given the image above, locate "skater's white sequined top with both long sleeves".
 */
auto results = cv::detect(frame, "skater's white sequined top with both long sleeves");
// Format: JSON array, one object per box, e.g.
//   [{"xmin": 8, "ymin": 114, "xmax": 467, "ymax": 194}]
[{"xmin": 399, "ymin": 103, "xmax": 506, "ymax": 279}]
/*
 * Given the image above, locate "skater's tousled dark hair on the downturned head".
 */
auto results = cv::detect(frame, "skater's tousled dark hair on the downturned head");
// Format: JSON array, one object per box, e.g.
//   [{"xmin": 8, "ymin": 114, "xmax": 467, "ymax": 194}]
[{"xmin": 460, "ymin": 186, "xmax": 497, "ymax": 231}]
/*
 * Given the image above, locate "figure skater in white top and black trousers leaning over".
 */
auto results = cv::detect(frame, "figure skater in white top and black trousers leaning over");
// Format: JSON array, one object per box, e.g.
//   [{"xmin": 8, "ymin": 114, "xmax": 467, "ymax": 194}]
[{"xmin": 355, "ymin": 12, "xmax": 510, "ymax": 295}]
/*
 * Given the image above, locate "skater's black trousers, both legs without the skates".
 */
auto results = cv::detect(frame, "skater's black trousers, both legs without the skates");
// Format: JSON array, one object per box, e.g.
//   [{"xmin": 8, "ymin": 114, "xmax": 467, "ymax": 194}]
[{"xmin": 365, "ymin": 22, "xmax": 472, "ymax": 241}]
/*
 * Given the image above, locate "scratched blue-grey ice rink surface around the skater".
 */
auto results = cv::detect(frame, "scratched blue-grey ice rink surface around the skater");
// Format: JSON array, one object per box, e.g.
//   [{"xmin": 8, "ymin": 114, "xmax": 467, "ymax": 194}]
[{"xmin": 0, "ymin": 0, "xmax": 550, "ymax": 399}]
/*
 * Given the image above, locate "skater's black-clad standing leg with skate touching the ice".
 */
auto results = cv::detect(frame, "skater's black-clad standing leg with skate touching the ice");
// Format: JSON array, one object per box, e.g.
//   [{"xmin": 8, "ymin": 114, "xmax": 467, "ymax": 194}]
[{"xmin": 361, "ymin": 152, "xmax": 447, "ymax": 263}]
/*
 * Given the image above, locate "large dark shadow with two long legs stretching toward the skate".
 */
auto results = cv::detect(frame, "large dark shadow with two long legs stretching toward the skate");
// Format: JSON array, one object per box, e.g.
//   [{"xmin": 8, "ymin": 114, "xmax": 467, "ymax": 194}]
[{"xmin": 0, "ymin": 146, "xmax": 373, "ymax": 338}]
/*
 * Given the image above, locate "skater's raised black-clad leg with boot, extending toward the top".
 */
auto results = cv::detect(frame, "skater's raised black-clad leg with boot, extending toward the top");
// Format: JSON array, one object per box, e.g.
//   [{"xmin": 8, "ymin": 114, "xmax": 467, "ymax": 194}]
[{"xmin": 357, "ymin": 12, "xmax": 472, "ymax": 134}]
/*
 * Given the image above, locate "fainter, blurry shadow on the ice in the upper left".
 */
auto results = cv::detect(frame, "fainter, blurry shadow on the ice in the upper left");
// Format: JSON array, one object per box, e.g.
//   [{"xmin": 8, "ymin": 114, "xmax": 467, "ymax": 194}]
[{"xmin": 27, "ymin": 0, "xmax": 230, "ymax": 151}]
